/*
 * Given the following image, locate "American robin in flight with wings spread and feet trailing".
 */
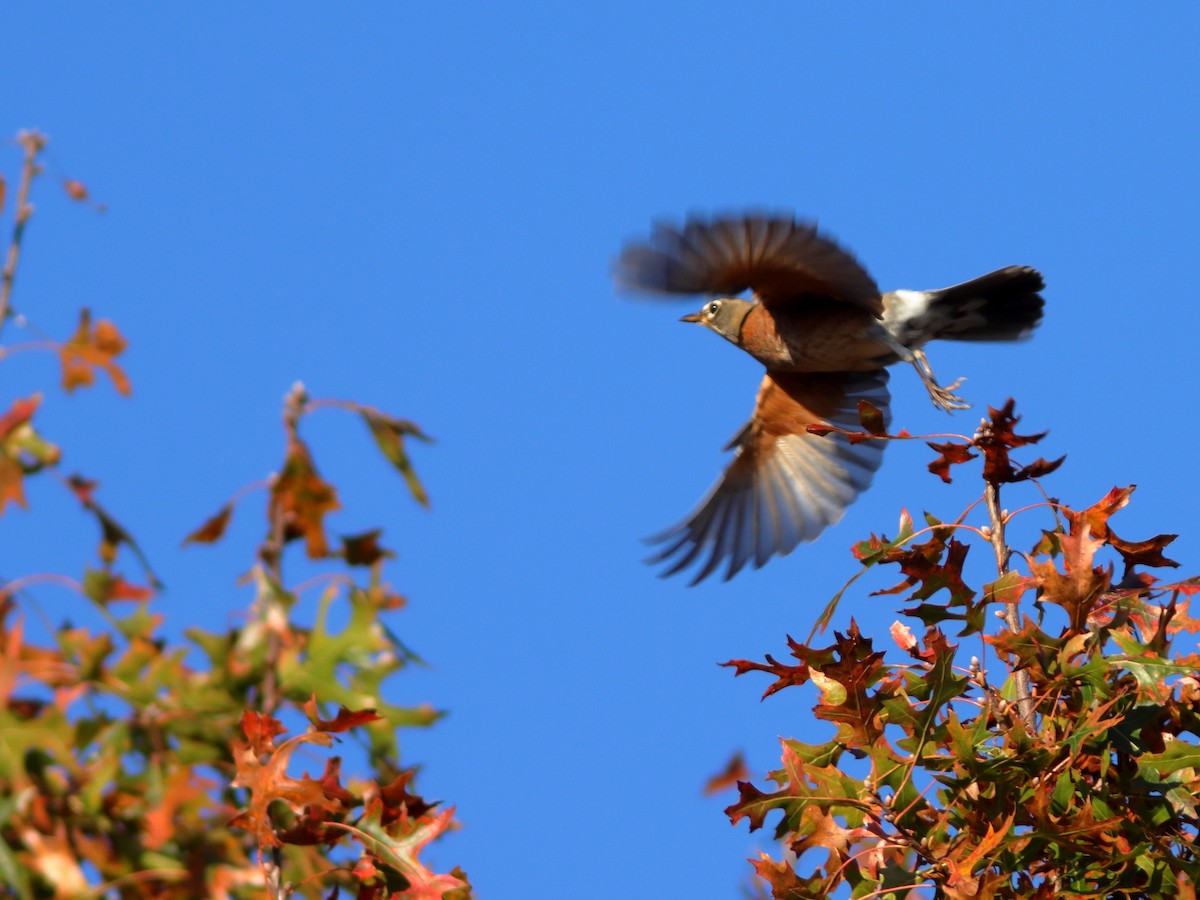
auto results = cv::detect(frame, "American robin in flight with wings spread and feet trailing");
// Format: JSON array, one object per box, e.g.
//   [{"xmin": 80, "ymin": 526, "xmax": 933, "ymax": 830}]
[{"xmin": 616, "ymin": 215, "xmax": 1044, "ymax": 584}]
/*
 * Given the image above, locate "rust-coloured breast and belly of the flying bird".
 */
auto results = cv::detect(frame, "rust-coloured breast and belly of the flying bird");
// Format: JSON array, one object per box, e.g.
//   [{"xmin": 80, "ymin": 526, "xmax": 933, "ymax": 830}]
[{"xmin": 738, "ymin": 300, "xmax": 889, "ymax": 372}]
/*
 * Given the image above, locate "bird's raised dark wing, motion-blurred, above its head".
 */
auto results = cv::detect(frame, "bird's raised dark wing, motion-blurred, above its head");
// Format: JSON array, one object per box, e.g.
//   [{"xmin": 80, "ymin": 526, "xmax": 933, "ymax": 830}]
[{"xmin": 616, "ymin": 215, "xmax": 883, "ymax": 314}]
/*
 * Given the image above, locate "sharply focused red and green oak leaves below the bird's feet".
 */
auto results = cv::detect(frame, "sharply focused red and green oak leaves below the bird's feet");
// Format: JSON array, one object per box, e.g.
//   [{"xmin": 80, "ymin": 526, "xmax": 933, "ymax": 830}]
[{"xmin": 726, "ymin": 401, "xmax": 1200, "ymax": 900}]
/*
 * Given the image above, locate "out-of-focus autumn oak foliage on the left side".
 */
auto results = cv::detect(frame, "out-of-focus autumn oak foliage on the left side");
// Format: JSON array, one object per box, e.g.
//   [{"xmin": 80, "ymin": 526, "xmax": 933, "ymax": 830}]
[{"xmin": 0, "ymin": 133, "xmax": 472, "ymax": 900}]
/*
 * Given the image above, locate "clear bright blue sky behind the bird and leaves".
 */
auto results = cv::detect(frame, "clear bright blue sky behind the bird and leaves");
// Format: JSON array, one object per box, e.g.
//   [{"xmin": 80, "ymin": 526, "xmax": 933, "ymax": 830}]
[{"xmin": 0, "ymin": 1, "xmax": 1200, "ymax": 900}]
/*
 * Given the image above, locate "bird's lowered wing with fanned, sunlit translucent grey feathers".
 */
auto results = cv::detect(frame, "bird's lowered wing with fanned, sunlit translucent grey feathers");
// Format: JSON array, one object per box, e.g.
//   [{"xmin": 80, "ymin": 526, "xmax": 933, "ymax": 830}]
[{"xmin": 648, "ymin": 370, "xmax": 890, "ymax": 584}]
